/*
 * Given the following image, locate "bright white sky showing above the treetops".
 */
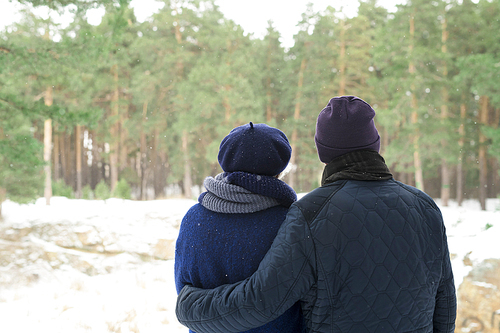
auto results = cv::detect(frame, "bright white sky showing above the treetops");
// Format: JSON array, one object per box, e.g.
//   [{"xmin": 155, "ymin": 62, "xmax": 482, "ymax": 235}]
[{"xmin": 0, "ymin": 0, "xmax": 404, "ymax": 47}]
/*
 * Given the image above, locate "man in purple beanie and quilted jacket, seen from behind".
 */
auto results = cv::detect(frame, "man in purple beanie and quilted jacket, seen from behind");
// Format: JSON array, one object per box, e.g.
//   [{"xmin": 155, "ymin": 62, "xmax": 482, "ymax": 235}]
[{"xmin": 176, "ymin": 96, "xmax": 456, "ymax": 333}]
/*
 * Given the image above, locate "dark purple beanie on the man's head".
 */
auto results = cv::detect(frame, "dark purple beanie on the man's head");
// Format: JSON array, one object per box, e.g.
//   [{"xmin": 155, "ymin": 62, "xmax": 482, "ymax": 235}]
[{"xmin": 314, "ymin": 96, "xmax": 380, "ymax": 163}]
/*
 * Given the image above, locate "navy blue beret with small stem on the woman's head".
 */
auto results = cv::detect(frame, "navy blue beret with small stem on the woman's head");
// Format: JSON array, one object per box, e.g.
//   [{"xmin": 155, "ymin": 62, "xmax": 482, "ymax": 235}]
[{"xmin": 218, "ymin": 122, "xmax": 292, "ymax": 176}]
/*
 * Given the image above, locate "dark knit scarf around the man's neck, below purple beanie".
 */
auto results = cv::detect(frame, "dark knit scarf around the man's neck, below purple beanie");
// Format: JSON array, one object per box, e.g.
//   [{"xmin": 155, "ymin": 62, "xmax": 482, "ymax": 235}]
[{"xmin": 321, "ymin": 150, "xmax": 392, "ymax": 186}]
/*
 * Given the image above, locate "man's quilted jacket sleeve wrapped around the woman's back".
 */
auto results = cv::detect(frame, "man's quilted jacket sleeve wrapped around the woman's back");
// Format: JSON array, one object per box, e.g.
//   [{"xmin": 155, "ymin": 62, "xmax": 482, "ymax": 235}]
[{"xmin": 176, "ymin": 205, "xmax": 316, "ymax": 333}]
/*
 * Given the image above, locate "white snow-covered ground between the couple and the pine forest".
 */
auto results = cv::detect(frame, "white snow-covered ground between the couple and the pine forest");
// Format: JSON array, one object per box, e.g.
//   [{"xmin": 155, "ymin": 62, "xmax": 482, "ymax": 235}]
[{"xmin": 0, "ymin": 198, "xmax": 500, "ymax": 333}]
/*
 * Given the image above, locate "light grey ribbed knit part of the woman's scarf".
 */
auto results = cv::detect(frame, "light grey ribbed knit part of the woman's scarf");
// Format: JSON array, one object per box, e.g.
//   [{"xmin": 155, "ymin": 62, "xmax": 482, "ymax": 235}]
[{"xmin": 198, "ymin": 173, "xmax": 280, "ymax": 213}]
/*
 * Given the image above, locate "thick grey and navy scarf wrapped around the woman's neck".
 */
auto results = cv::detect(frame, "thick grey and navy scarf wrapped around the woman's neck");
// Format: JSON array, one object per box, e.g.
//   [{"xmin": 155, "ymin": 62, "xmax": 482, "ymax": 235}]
[{"xmin": 198, "ymin": 172, "xmax": 297, "ymax": 213}]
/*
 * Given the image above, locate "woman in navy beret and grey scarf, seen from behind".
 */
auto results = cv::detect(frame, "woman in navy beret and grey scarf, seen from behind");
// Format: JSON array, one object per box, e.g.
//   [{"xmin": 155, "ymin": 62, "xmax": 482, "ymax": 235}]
[{"xmin": 175, "ymin": 123, "xmax": 305, "ymax": 333}]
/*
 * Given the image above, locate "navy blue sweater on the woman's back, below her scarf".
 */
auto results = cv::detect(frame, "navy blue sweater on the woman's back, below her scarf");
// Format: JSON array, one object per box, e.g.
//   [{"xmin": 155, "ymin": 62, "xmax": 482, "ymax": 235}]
[{"xmin": 175, "ymin": 204, "xmax": 305, "ymax": 332}]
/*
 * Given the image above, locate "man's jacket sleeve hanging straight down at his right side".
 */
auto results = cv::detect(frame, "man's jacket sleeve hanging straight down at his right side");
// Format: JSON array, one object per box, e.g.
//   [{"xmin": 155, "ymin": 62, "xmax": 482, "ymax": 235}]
[{"xmin": 433, "ymin": 214, "xmax": 457, "ymax": 333}]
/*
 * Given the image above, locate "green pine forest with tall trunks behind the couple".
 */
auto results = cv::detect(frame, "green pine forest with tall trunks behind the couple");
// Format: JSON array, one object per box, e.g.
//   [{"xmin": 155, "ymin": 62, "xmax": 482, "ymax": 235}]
[{"xmin": 0, "ymin": 0, "xmax": 500, "ymax": 212}]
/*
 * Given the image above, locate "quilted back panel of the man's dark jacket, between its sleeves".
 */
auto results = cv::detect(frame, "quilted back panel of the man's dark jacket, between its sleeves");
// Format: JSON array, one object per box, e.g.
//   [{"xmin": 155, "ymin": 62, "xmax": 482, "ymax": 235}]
[{"xmin": 298, "ymin": 181, "xmax": 452, "ymax": 332}]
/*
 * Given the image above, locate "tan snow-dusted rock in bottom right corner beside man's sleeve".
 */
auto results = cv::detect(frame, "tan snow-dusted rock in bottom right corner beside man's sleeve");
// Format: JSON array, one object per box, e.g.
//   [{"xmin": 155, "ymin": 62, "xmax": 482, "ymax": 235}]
[{"xmin": 455, "ymin": 259, "xmax": 500, "ymax": 333}]
